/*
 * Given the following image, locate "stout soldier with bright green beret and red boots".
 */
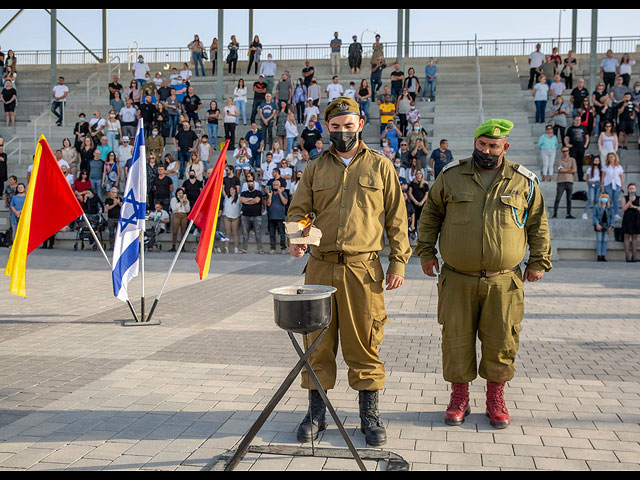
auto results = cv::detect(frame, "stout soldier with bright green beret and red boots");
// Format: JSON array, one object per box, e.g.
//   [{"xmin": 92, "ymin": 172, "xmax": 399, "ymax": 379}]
[{"xmin": 415, "ymin": 119, "xmax": 551, "ymax": 428}]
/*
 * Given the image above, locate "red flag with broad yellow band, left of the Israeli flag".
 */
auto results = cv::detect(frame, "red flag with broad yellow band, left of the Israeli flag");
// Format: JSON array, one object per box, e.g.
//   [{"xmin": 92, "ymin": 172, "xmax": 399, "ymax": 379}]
[{"xmin": 4, "ymin": 135, "xmax": 84, "ymax": 298}]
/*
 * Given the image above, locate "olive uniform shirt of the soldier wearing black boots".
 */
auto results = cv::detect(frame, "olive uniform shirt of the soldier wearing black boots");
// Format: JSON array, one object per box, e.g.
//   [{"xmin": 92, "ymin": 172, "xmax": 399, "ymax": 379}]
[{"xmin": 288, "ymin": 141, "xmax": 411, "ymax": 276}]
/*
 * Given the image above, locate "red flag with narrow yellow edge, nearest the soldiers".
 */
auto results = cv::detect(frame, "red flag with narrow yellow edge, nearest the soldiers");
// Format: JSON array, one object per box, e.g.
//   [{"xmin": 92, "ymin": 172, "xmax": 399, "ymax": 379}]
[{"xmin": 189, "ymin": 140, "xmax": 229, "ymax": 280}]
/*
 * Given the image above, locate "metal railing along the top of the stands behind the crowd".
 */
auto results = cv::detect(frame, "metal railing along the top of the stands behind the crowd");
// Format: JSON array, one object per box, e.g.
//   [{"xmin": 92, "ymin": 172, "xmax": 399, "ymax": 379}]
[{"xmin": 10, "ymin": 36, "xmax": 640, "ymax": 67}]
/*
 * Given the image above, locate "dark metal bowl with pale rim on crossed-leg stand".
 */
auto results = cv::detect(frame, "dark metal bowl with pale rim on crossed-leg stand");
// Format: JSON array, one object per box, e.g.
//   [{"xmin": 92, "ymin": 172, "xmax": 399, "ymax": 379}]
[{"xmin": 269, "ymin": 285, "xmax": 336, "ymax": 334}]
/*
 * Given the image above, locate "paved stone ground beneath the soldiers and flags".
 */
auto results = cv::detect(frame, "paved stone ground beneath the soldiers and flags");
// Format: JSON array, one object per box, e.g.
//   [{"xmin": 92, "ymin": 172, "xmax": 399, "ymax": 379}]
[{"xmin": 0, "ymin": 250, "xmax": 640, "ymax": 470}]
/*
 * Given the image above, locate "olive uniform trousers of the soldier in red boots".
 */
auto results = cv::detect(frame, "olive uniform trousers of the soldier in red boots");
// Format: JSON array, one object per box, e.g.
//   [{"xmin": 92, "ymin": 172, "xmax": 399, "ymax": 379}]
[{"xmin": 438, "ymin": 266, "xmax": 524, "ymax": 383}]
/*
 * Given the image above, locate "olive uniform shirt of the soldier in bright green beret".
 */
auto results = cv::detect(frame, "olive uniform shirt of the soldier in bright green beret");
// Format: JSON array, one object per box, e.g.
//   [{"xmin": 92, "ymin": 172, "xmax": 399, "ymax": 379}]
[{"xmin": 415, "ymin": 158, "xmax": 551, "ymax": 271}]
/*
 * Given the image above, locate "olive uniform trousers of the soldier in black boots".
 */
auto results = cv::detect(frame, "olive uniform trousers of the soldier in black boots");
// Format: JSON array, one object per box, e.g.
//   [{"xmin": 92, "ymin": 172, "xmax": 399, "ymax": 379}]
[{"xmin": 302, "ymin": 253, "xmax": 387, "ymax": 391}]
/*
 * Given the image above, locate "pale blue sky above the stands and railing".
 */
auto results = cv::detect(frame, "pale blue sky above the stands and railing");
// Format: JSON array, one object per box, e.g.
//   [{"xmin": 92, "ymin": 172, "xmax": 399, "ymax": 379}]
[{"xmin": 0, "ymin": 9, "xmax": 640, "ymax": 53}]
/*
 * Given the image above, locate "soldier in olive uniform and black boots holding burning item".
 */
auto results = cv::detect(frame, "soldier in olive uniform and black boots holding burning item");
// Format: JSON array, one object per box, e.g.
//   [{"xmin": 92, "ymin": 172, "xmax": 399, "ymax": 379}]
[{"xmin": 288, "ymin": 97, "xmax": 411, "ymax": 446}]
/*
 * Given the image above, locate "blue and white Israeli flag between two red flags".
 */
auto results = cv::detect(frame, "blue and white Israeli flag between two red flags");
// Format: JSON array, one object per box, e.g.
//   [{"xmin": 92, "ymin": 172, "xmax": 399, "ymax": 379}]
[{"xmin": 112, "ymin": 119, "xmax": 147, "ymax": 302}]
